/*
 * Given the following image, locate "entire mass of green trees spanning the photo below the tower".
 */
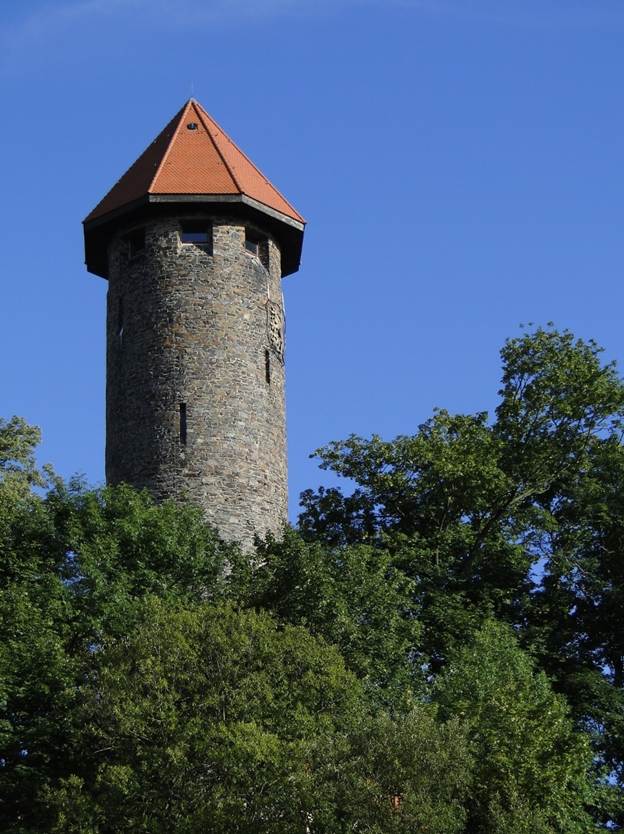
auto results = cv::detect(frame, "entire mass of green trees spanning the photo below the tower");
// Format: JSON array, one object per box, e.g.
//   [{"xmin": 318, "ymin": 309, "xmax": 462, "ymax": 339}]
[{"xmin": 0, "ymin": 328, "xmax": 624, "ymax": 834}]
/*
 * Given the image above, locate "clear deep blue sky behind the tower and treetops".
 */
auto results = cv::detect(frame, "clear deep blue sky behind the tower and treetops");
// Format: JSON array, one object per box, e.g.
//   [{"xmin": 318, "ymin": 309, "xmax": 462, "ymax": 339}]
[{"xmin": 0, "ymin": 0, "xmax": 624, "ymax": 515}]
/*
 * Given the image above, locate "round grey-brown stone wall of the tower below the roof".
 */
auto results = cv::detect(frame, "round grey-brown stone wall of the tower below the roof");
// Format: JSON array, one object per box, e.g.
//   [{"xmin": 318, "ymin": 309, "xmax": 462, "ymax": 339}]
[{"xmin": 106, "ymin": 214, "xmax": 287, "ymax": 546}]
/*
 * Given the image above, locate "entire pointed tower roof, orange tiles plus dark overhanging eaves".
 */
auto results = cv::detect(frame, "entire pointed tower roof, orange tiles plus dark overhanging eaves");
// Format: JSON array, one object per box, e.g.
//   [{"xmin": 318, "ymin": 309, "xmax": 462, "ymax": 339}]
[{"xmin": 83, "ymin": 99, "xmax": 305, "ymax": 278}]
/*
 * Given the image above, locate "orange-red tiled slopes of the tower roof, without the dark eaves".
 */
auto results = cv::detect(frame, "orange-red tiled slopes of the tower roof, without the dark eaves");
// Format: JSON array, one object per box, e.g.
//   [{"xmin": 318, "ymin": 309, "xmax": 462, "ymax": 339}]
[{"xmin": 85, "ymin": 99, "xmax": 305, "ymax": 223}]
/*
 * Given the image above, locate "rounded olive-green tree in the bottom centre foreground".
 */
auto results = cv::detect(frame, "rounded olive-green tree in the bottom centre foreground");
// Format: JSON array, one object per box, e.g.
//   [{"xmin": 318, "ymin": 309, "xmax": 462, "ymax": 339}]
[{"xmin": 48, "ymin": 598, "xmax": 470, "ymax": 834}]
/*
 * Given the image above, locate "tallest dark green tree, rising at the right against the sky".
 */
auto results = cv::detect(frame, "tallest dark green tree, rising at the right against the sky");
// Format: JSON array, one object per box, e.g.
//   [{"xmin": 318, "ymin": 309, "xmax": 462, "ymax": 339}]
[{"xmin": 300, "ymin": 328, "xmax": 624, "ymax": 824}]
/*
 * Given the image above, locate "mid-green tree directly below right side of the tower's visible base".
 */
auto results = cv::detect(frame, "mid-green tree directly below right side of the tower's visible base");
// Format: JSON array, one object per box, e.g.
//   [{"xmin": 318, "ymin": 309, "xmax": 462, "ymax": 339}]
[{"xmin": 228, "ymin": 530, "xmax": 423, "ymax": 705}]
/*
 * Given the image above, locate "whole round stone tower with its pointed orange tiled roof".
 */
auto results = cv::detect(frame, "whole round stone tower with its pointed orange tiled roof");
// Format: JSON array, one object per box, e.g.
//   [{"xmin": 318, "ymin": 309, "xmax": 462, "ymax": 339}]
[{"xmin": 84, "ymin": 99, "xmax": 304, "ymax": 545}]
